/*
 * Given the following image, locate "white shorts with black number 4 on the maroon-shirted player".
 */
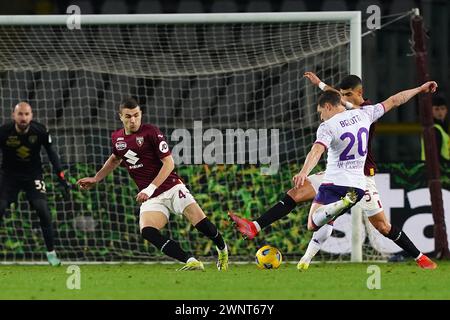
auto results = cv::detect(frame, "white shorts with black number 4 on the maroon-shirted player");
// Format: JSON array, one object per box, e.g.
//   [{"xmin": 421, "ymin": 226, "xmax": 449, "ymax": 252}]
[{"xmin": 140, "ymin": 183, "xmax": 196, "ymax": 220}]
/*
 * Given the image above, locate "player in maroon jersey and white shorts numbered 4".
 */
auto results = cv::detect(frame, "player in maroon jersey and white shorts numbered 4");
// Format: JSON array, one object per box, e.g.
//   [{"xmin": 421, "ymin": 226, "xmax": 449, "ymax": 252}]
[{"xmin": 77, "ymin": 98, "xmax": 228, "ymax": 270}]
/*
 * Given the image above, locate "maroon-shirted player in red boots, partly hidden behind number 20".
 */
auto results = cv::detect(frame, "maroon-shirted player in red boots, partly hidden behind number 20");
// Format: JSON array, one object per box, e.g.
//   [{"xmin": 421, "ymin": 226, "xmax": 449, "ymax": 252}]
[{"xmin": 229, "ymin": 72, "xmax": 436, "ymax": 270}]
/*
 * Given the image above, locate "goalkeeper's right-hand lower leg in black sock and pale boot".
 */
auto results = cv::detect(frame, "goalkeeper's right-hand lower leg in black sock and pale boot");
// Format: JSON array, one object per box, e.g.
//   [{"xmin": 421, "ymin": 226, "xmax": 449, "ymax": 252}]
[{"xmin": 30, "ymin": 199, "xmax": 61, "ymax": 267}]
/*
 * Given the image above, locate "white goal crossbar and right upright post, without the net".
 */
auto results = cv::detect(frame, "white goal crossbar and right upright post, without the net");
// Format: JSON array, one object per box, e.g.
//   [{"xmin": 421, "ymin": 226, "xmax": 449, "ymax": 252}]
[{"xmin": 0, "ymin": 11, "xmax": 363, "ymax": 263}]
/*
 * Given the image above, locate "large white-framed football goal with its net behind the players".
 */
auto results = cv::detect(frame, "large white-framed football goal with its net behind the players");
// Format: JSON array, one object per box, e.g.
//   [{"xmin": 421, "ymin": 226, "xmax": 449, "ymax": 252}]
[{"xmin": 0, "ymin": 11, "xmax": 376, "ymax": 262}]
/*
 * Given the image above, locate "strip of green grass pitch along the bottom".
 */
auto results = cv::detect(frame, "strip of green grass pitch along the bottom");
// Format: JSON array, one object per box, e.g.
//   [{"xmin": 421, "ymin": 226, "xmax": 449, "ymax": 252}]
[{"xmin": 0, "ymin": 261, "xmax": 450, "ymax": 300}]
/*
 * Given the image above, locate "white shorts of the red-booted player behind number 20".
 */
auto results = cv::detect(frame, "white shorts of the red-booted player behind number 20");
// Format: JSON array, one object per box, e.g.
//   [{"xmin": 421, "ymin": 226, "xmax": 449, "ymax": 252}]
[{"xmin": 308, "ymin": 172, "xmax": 383, "ymax": 217}]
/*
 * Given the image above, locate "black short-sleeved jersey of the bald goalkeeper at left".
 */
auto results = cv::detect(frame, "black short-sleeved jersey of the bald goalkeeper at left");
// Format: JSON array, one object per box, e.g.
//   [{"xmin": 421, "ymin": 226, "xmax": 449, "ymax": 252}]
[{"xmin": 0, "ymin": 121, "xmax": 52, "ymax": 179}]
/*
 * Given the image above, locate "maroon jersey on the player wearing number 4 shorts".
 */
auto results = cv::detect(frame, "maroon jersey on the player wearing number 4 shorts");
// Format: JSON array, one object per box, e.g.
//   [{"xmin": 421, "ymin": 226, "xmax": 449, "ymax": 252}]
[{"xmin": 111, "ymin": 124, "xmax": 183, "ymax": 198}]
